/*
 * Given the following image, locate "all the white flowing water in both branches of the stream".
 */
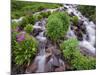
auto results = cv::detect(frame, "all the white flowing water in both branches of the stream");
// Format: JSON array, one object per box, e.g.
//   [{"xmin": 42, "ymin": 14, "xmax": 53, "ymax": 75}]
[{"xmin": 12, "ymin": 4, "xmax": 96, "ymax": 72}]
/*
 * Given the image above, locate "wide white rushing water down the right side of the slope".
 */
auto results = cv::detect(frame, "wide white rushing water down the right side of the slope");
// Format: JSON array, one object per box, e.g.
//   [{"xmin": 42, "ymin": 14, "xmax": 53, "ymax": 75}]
[{"xmin": 64, "ymin": 5, "xmax": 96, "ymax": 55}]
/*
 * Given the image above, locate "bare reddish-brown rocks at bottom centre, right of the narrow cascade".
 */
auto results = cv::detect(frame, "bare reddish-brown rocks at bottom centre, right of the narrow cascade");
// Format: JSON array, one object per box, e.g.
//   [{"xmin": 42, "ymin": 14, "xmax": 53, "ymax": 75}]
[{"xmin": 45, "ymin": 47, "xmax": 65, "ymax": 72}]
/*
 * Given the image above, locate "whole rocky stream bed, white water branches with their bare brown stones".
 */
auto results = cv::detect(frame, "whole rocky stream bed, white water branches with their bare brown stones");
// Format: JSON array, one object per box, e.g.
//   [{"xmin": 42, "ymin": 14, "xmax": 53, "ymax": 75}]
[{"xmin": 12, "ymin": 4, "xmax": 96, "ymax": 73}]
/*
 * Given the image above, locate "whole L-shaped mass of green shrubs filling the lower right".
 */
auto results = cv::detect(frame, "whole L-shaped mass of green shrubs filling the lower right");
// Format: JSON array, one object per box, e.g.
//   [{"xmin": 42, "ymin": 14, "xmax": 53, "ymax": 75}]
[{"xmin": 60, "ymin": 38, "xmax": 96, "ymax": 70}]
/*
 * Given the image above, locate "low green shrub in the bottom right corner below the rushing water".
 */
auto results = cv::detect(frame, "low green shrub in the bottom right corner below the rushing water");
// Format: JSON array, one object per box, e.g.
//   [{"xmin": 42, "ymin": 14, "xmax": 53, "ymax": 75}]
[{"xmin": 71, "ymin": 53, "xmax": 96, "ymax": 70}]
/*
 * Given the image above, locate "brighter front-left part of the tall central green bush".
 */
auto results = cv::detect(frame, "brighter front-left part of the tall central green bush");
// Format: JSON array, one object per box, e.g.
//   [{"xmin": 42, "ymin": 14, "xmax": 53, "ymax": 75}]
[{"xmin": 47, "ymin": 18, "xmax": 64, "ymax": 41}]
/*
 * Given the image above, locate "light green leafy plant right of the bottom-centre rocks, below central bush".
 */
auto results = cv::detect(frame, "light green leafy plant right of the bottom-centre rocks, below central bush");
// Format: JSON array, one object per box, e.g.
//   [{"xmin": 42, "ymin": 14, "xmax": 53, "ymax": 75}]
[{"xmin": 60, "ymin": 38, "xmax": 79, "ymax": 60}]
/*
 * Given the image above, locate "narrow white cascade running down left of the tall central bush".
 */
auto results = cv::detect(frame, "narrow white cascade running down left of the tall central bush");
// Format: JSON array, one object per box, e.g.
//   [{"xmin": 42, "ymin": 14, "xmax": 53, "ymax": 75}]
[{"xmin": 34, "ymin": 20, "xmax": 46, "ymax": 72}]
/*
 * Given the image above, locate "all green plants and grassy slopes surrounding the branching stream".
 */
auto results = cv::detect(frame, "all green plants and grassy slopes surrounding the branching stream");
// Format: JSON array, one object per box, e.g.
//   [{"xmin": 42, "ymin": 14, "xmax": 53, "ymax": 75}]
[{"xmin": 11, "ymin": 0, "xmax": 96, "ymax": 70}]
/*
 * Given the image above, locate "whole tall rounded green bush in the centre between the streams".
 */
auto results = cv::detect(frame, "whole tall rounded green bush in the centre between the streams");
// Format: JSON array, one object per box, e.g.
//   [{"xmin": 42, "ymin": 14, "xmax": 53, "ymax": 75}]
[{"xmin": 46, "ymin": 12, "xmax": 69, "ymax": 42}]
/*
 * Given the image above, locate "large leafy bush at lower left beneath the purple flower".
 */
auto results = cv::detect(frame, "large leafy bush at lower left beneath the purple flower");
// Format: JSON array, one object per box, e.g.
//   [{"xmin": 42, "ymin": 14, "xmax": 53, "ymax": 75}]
[{"xmin": 11, "ymin": 32, "xmax": 37, "ymax": 65}]
